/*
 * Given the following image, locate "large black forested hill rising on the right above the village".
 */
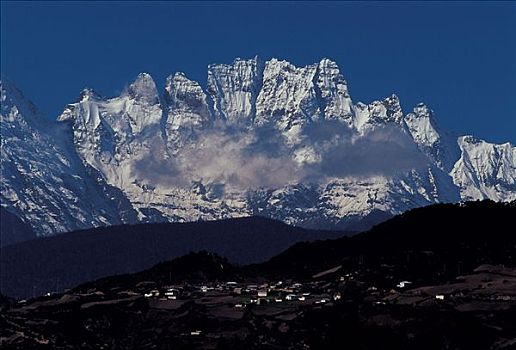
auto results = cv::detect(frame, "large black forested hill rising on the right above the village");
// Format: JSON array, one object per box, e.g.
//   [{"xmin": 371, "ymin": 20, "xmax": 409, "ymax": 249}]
[{"xmin": 250, "ymin": 201, "xmax": 516, "ymax": 279}]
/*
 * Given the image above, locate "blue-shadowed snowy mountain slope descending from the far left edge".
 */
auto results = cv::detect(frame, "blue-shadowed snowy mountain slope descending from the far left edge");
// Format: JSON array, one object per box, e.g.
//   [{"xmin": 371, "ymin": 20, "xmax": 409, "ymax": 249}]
[{"xmin": 0, "ymin": 79, "xmax": 136, "ymax": 234}]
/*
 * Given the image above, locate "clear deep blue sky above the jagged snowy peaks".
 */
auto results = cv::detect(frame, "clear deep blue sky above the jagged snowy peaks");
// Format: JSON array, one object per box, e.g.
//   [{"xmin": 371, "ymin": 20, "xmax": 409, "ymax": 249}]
[{"xmin": 1, "ymin": 1, "xmax": 516, "ymax": 143}]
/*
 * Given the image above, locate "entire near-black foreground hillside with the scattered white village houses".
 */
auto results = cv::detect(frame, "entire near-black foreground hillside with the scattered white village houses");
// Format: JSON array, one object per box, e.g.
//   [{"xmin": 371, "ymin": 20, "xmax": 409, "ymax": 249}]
[{"xmin": 0, "ymin": 201, "xmax": 516, "ymax": 349}]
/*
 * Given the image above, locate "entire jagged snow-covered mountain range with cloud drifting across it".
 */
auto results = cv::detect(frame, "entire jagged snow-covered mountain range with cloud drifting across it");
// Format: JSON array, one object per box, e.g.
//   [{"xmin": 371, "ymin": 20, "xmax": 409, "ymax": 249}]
[{"xmin": 1, "ymin": 58, "xmax": 516, "ymax": 238}]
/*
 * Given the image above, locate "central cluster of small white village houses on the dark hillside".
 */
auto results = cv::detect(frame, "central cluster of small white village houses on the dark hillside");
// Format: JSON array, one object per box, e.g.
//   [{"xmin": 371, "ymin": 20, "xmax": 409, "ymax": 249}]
[{"xmin": 127, "ymin": 274, "xmax": 354, "ymax": 337}]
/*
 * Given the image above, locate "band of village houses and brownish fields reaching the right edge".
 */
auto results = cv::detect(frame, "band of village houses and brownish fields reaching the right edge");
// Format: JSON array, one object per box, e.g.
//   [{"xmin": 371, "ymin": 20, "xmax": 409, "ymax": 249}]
[{"xmin": 135, "ymin": 265, "xmax": 516, "ymax": 335}]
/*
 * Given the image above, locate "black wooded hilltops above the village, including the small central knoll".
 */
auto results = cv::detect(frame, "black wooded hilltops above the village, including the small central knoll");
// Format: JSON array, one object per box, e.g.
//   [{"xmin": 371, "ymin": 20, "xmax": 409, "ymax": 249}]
[{"xmin": 69, "ymin": 201, "xmax": 516, "ymax": 287}]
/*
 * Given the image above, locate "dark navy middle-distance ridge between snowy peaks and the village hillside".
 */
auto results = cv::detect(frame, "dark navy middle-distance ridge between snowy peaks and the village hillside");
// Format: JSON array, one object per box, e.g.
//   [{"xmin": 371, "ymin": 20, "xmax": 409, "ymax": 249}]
[{"xmin": 0, "ymin": 217, "xmax": 346, "ymax": 298}]
